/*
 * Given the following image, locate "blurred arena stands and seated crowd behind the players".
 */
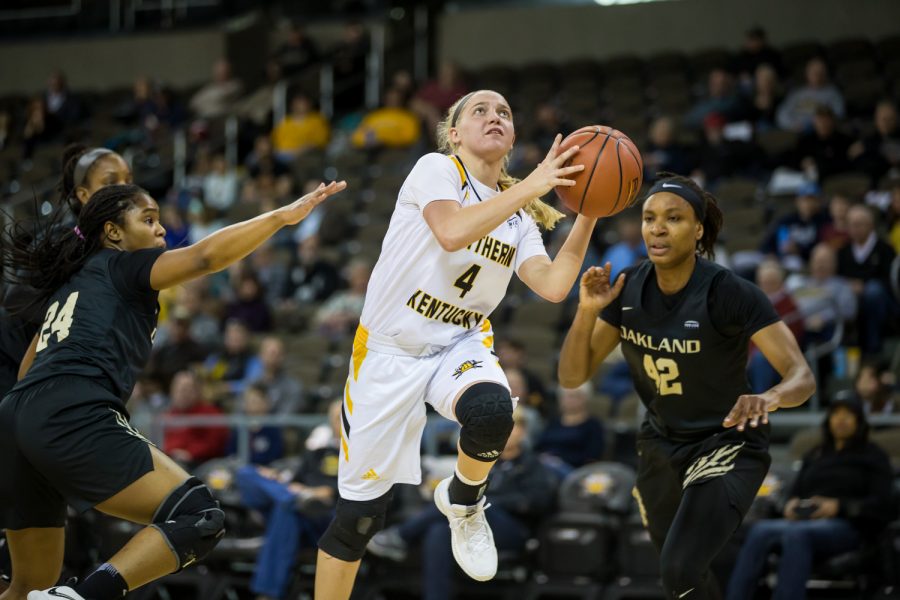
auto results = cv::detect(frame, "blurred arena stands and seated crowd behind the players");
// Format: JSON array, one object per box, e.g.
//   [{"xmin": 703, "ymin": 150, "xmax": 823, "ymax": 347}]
[{"xmin": 0, "ymin": 0, "xmax": 900, "ymax": 600}]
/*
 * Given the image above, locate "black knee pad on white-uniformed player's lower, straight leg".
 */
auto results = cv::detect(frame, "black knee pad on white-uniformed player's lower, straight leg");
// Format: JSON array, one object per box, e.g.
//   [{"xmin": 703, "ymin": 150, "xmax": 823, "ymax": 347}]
[{"xmin": 319, "ymin": 489, "xmax": 394, "ymax": 562}]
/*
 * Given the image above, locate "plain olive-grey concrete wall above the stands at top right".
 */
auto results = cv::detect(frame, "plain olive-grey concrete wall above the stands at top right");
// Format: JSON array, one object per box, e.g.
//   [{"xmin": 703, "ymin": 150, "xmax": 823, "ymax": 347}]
[{"xmin": 439, "ymin": 0, "xmax": 900, "ymax": 68}]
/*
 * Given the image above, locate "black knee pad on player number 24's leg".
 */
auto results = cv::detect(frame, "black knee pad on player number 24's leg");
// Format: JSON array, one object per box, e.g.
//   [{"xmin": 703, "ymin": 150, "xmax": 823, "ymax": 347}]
[{"xmin": 152, "ymin": 477, "xmax": 225, "ymax": 571}]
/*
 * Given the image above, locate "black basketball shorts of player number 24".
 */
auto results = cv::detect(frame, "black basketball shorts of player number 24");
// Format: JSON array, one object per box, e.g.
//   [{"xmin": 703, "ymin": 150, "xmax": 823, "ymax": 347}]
[{"xmin": 0, "ymin": 375, "xmax": 153, "ymax": 530}]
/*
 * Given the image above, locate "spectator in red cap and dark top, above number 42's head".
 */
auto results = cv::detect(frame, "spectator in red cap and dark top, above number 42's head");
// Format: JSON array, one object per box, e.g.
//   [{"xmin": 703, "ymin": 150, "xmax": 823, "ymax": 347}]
[{"xmin": 692, "ymin": 113, "xmax": 763, "ymax": 185}]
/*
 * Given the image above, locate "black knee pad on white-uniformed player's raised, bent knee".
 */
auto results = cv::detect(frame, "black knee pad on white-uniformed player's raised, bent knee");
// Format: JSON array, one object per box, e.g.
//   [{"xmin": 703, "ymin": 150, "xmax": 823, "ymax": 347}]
[{"xmin": 456, "ymin": 382, "xmax": 513, "ymax": 462}]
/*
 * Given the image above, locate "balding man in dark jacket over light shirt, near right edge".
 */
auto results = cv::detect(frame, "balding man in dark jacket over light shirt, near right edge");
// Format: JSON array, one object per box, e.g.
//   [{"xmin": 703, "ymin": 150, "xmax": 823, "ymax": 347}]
[{"xmin": 838, "ymin": 204, "xmax": 900, "ymax": 355}]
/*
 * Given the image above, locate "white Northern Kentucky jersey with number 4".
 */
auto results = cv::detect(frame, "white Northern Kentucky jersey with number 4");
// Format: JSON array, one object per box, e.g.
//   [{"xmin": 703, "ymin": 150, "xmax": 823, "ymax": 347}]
[{"xmin": 360, "ymin": 153, "xmax": 547, "ymax": 355}]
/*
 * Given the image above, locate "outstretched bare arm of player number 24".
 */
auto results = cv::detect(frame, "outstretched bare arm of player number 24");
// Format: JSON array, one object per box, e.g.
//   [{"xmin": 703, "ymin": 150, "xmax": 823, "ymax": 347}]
[{"xmin": 150, "ymin": 181, "xmax": 347, "ymax": 290}]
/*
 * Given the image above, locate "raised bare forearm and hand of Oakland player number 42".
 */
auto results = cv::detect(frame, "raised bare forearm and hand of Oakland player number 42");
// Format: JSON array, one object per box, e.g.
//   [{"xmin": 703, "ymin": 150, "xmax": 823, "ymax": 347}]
[{"xmin": 557, "ymin": 263, "xmax": 625, "ymax": 388}]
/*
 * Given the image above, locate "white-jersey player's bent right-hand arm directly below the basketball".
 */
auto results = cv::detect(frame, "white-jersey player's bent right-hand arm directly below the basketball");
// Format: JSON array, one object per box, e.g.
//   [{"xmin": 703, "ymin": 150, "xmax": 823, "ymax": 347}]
[{"xmin": 519, "ymin": 215, "xmax": 597, "ymax": 302}]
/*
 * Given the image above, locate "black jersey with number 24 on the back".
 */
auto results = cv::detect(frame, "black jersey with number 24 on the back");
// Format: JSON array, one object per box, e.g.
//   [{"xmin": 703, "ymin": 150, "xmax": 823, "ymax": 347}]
[{"xmin": 14, "ymin": 248, "xmax": 164, "ymax": 403}]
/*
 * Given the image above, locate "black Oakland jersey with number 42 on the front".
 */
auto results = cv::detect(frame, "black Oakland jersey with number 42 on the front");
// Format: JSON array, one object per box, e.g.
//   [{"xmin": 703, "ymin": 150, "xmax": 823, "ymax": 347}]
[{"xmin": 603, "ymin": 258, "xmax": 778, "ymax": 441}]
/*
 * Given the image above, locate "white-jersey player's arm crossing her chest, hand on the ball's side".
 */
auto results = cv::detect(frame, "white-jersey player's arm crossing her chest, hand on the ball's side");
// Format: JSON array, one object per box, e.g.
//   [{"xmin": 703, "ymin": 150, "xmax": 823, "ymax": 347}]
[{"xmin": 422, "ymin": 135, "xmax": 584, "ymax": 252}]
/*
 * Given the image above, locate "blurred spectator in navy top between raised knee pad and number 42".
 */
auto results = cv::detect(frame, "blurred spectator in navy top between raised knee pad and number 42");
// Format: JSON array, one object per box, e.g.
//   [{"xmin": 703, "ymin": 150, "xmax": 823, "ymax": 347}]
[{"xmin": 536, "ymin": 381, "xmax": 606, "ymax": 468}]
